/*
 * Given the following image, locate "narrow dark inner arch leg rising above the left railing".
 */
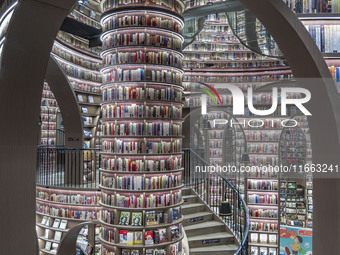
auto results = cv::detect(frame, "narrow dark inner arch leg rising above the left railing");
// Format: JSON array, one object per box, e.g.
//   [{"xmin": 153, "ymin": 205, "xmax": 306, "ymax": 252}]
[{"xmin": 46, "ymin": 56, "xmax": 83, "ymax": 148}]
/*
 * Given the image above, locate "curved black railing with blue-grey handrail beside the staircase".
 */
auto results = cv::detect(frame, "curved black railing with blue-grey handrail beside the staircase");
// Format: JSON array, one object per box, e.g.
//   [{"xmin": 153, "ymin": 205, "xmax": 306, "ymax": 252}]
[{"xmin": 183, "ymin": 149, "xmax": 250, "ymax": 255}]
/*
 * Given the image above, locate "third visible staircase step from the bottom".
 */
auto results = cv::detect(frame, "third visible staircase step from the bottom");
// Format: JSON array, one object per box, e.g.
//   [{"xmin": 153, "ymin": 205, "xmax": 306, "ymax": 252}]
[{"xmin": 184, "ymin": 221, "xmax": 225, "ymax": 238}]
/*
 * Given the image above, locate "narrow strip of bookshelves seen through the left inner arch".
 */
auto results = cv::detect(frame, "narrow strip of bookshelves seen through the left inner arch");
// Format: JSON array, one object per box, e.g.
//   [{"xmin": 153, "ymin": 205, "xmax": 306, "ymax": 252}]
[{"xmin": 39, "ymin": 82, "xmax": 58, "ymax": 147}]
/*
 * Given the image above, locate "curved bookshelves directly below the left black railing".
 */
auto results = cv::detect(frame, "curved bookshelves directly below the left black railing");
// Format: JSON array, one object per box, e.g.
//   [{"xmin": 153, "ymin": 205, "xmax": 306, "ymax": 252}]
[{"xmin": 36, "ymin": 186, "xmax": 100, "ymax": 254}]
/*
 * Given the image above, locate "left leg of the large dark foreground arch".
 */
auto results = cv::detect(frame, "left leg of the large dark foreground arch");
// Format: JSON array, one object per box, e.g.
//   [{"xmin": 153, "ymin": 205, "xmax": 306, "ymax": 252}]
[{"xmin": 0, "ymin": 0, "xmax": 76, "ymax": 255}]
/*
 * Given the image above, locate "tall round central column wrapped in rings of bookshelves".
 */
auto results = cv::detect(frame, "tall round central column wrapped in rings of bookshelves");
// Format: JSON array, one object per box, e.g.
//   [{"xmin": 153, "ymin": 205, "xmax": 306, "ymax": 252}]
[{"xmin": 99, "ymin": 1, "xmax": 184, "ymax": 255}]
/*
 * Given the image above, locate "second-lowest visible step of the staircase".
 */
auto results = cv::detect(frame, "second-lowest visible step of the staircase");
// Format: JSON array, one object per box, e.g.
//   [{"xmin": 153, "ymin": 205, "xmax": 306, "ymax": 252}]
[{"xmin": 188, "ymin": 232, "xmax": 234, "ymax": 249}]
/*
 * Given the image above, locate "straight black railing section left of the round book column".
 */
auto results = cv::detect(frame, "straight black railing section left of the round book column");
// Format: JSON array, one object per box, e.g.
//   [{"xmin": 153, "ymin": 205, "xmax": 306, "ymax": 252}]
[{"xmin": 36, "ymin": 147, "xmax": 100, "ymax": 189}]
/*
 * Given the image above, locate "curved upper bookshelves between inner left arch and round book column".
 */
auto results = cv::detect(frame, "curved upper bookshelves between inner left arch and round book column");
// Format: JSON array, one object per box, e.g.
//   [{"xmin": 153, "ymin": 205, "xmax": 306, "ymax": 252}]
[{"xmin": 52, "ymin": 7, "xmax": 102, "ymax": 148}]
